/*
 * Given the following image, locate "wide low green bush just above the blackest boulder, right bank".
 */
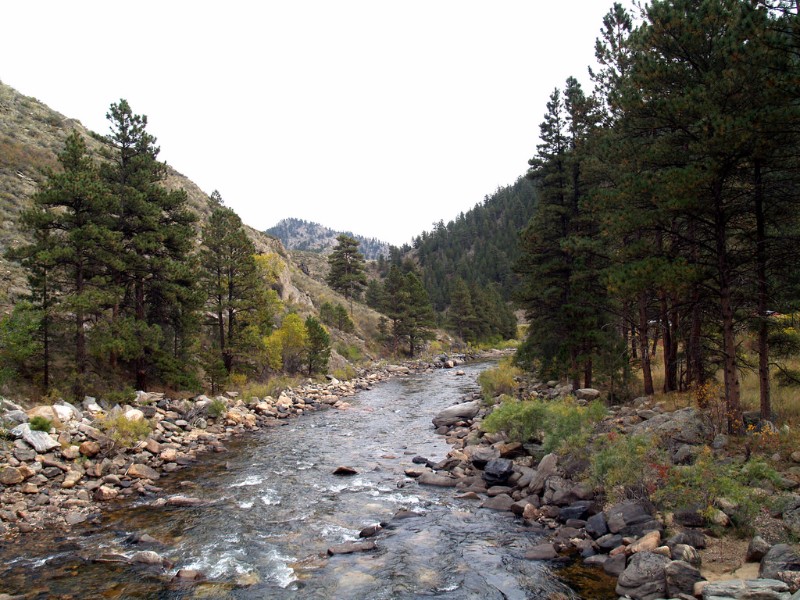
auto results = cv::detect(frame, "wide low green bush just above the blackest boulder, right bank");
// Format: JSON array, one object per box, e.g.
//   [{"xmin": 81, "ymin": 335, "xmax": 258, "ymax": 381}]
[{"xmin": 481, "ymin": 396, "xmax": 606, "ymax": 452}]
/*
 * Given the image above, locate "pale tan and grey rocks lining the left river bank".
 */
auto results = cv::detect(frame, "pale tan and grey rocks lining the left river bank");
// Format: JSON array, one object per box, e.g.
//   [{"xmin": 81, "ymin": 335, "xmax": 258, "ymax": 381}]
[{"xmin": 0, "ymin": 357, "xmax": 476, "ymax": 539}]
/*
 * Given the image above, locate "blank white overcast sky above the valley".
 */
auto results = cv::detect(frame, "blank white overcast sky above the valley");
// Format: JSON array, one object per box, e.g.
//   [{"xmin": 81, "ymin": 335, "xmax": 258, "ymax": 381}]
[{"xmin": 0, "ymin": 0, "xmax": 612, "ymax": 245}]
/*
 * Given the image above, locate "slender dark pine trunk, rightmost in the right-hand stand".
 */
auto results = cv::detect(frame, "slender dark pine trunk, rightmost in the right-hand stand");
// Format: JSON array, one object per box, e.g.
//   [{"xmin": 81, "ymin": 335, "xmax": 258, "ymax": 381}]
[{"xmin": 754, "ymin": 160, "xmax": 772, "ymax": 421}]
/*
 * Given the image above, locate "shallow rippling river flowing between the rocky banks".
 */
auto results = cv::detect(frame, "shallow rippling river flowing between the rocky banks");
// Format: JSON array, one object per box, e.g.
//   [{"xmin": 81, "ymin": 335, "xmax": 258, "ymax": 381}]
[{"xmin": 0, "ymin": 364, "xmax": 608, "ymax": 600}]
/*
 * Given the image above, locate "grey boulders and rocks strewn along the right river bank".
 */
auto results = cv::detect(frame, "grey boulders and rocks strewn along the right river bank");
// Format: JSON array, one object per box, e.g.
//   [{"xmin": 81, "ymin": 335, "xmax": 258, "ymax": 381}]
[{"xmin": 418, "ymin": 382, "xmax": 800, "ymax": 600}]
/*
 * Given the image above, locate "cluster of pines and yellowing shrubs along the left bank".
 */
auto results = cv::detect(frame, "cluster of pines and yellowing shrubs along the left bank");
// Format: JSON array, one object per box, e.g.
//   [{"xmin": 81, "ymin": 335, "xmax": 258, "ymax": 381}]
[{"xmin": 0, "ymin": 100, "xmax": 330, "ymax": 399}]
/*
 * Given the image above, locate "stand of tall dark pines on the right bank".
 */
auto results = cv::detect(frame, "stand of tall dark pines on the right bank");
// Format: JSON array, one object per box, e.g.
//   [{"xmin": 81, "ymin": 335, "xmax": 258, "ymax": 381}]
[{"xmin": 517, "ymin": 0, "xmax": 800, "ymax": 431}]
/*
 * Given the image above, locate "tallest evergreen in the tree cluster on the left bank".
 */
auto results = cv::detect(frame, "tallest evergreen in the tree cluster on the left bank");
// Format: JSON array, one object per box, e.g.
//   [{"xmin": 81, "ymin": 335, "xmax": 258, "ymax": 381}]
[{"xmin": 103, "ymin": 100, "xmax": 196, "ymax": 389}]
